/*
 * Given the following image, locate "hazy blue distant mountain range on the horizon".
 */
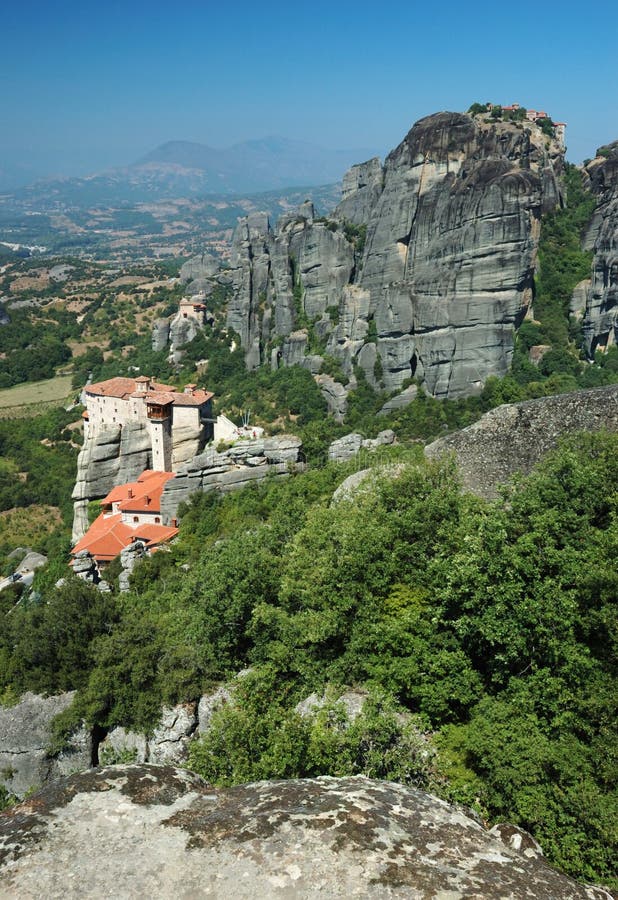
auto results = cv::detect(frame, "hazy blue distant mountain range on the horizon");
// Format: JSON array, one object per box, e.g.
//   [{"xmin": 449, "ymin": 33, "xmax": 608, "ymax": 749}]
[{"xmin": 0, "ymin": 137, "xmax": 376, "ymax": 206}]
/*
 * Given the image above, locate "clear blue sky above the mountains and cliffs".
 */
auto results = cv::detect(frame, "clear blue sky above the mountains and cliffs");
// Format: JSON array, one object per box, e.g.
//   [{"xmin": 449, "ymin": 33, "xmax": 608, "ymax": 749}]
[{"xmin": 0, "ymin": 0, "xmax": 618, "ymax": 174}]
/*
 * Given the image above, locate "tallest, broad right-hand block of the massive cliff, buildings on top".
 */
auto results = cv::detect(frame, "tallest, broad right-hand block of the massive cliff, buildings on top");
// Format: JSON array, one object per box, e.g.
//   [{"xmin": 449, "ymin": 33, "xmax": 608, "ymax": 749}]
[{"xmin": 357, "ymin": 113, "xmax": 561, "ymax": 397}]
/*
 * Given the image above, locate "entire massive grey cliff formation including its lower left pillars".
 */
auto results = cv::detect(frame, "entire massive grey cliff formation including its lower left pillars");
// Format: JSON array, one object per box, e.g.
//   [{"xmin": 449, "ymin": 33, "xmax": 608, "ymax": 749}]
[{"xmin": 228, "ymin": 113, "xmax": 563, "ymax": 397}]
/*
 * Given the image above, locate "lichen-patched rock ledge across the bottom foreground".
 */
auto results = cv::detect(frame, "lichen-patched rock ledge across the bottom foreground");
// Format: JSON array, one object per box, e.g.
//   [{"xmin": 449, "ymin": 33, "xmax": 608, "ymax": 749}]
[{"xmin": 0, "ymin": 765, "xmax": 611, "ymax": 900}]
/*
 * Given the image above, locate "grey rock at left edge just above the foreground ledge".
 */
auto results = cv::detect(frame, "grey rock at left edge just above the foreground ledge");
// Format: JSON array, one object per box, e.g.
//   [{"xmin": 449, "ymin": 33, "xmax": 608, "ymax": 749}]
[{"xmin": 0, "ymin": 691, "xmax": 92, "ymax": 797}]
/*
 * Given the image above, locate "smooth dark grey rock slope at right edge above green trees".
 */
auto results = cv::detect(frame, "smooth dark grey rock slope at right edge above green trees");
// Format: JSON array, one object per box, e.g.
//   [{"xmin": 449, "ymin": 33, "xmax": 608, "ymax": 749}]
[{"xmin": 425, "ymin": 385, "xmax": 618, "ymax": 498}]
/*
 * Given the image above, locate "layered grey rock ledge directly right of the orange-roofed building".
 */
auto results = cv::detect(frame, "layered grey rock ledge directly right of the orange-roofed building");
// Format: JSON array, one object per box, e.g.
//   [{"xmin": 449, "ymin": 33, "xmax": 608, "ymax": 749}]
[{"xmin": 161, "ymin": 435, "xmax": 302, "ymax": 522}]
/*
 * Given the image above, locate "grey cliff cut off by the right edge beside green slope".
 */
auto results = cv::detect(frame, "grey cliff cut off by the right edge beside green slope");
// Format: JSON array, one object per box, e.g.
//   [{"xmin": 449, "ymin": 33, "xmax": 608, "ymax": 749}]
[{"xmin": 571, "ymin": 141, "xmax": 618, "ymax": 359}]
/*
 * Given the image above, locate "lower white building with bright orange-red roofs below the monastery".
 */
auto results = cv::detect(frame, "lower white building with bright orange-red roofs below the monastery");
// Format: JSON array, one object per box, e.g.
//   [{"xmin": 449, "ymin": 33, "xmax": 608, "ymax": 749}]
[{"xmin": 71, "ymin": 469, "xmax": 178, "ymax": 568}]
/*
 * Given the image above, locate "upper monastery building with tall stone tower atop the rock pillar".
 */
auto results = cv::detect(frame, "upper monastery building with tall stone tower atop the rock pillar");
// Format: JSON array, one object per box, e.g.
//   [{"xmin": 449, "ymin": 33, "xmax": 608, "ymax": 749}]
[{"xmin": 83, "ymin": 375, "xmax": 213, "ymax": 472}]
